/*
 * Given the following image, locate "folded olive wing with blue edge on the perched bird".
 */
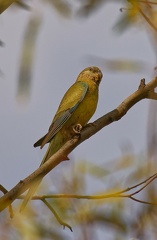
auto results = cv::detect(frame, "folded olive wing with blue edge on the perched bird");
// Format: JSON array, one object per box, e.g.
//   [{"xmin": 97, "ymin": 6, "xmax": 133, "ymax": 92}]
[{"xmin": 34, "ymin": 82, "xmax": 88, "ymax": 148}]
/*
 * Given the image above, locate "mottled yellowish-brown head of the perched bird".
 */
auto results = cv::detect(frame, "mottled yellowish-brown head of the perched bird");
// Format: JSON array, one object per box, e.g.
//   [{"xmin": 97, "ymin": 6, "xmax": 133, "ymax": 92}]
[{"xmin": 76, "ymin": 66, "xmax": 103, "ymax": 86}]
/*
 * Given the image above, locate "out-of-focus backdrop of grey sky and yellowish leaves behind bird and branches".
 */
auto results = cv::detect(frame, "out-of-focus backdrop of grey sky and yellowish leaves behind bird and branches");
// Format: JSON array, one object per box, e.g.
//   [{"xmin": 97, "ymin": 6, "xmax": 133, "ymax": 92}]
[{"xmin": 0, "ymin": 0, "xmax": 157, "ymax": 240}]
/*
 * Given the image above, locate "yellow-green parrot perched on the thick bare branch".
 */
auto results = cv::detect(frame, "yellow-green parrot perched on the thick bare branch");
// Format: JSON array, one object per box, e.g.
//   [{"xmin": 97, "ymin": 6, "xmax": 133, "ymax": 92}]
[{"xmin": 20, "ymin": 66, "xmax": 103, "ymax": 210}]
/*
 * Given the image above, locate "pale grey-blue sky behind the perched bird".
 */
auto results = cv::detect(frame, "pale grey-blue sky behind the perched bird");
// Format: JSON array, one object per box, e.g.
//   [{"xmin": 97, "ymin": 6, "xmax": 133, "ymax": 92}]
[{"xmin": 0, "ymin": 0, "xmax": 156, "ymax": 238}]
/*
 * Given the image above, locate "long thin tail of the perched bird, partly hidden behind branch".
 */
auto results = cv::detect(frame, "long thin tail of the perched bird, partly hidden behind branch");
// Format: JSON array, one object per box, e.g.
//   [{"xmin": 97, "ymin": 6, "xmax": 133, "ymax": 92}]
[{"xmin": 20, "ymin": 143, "xmax": 51, "ymax": 212}]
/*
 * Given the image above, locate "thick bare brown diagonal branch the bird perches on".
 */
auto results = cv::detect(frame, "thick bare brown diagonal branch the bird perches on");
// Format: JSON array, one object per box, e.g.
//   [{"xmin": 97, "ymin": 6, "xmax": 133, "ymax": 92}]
[{"xmin": 0, "ymin": 77, "xmax": 157, "ymax": 211}]
